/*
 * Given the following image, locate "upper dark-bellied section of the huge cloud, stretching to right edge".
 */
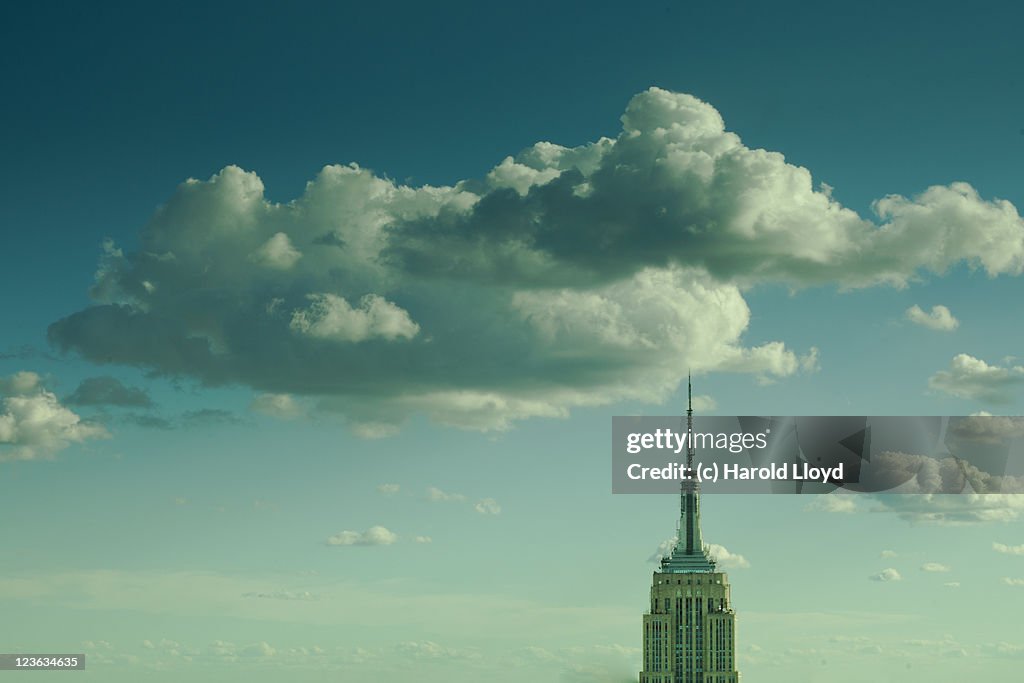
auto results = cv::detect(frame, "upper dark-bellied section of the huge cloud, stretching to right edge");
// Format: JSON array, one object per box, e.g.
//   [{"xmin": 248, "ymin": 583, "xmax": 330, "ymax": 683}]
[{"xmin": 389, "ymin": 89, "xmax": 1024, "ymax": 287}]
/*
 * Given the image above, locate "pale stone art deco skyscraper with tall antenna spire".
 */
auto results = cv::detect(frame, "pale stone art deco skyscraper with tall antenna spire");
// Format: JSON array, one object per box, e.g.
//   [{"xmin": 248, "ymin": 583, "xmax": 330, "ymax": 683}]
[{"xmin": 640, "ymin": 378, "xmax": 739, "ymax": 683}]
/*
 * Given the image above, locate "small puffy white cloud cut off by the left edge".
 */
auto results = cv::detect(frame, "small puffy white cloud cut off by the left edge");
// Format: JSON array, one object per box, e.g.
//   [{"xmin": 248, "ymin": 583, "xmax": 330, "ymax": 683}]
[{"xmin": 0, "ymin": 372, "xmax": 110, "ymax": 461}]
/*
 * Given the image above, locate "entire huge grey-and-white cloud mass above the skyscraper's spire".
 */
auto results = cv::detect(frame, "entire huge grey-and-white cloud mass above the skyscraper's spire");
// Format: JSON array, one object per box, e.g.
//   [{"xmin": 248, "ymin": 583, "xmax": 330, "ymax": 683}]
[{"xmin": 49, "ymin": 88, "xmax": 1024, "ymax": 434}]
